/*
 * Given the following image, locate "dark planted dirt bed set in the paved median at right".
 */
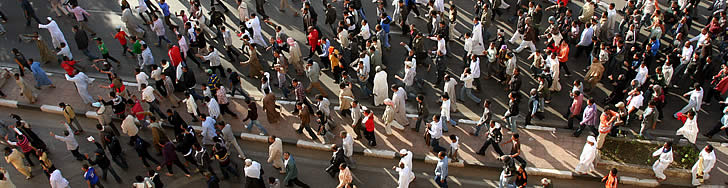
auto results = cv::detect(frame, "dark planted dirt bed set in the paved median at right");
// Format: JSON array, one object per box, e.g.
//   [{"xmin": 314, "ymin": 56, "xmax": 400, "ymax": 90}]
[{"xmin": 600, "ymin": 139, "xmax": 700, "ymax": 169}]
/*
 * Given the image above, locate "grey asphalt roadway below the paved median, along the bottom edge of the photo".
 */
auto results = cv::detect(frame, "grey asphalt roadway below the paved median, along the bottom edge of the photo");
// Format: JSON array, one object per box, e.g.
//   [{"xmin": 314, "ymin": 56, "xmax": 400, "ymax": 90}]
[{"xmin": 0, "ymin": 108, "xmax": 656, "ymax": 187}]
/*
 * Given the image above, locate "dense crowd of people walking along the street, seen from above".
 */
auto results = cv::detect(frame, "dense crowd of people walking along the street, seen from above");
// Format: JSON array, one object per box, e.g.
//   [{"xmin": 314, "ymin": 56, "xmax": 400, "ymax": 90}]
[{"xmin": 0, "ymin": 0, "xmax": 728, "ymax": 187}]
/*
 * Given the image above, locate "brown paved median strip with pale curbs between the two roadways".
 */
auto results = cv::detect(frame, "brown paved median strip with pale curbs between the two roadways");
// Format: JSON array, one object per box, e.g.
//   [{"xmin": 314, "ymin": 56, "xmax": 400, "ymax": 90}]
[{"xmin": 0, "ymin": 68, "xmax": 728, "ymax": 185}]
